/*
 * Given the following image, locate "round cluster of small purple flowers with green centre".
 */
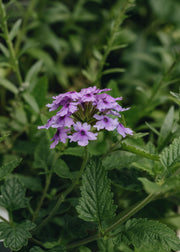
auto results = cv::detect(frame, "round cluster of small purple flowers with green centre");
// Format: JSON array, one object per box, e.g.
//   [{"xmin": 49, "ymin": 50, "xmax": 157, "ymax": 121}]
[{"xmin": 38, "ymin": 86, "xmax": 133, "ymax": 148}]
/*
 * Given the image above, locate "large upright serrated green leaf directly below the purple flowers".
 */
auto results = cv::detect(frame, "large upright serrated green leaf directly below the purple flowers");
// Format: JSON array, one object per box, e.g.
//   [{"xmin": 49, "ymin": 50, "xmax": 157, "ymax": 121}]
[{"xmin": 77, "ymin": 158, "xmax": 116, "ymax": 223}]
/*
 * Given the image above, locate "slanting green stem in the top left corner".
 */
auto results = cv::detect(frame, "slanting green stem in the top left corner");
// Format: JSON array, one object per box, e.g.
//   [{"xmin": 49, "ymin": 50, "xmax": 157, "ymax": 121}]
[{"xmin": 0, "ymin": 0, "xmax": 23, "ymax": 85}]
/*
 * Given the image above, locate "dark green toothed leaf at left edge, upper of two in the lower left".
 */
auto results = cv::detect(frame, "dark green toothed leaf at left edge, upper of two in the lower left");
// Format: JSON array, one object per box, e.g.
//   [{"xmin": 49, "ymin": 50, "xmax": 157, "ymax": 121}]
[{"xmin": 0, "ymin": 177, "xmax": 27, "ymax": 210}]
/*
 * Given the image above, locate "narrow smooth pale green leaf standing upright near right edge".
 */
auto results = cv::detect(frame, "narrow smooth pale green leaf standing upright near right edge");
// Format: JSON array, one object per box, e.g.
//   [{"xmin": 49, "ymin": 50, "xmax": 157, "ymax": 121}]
[{"xmin": 158, "ymin": 107, "xmax": 174, "ymax": 147}]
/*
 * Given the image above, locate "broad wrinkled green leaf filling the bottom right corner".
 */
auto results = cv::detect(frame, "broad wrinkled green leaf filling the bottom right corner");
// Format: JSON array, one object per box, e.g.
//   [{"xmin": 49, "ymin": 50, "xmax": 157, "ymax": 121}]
[{"xmin": 115, "ymin": 218, "xmax": 180, "ymax": 252}]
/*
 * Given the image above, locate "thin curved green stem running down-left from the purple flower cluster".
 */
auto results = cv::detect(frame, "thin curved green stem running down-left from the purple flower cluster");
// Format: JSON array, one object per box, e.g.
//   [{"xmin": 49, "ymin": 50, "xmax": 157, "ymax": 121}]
[{"xmin": 34, "ymin": 147, "xmax": 88, "ymax": 232}]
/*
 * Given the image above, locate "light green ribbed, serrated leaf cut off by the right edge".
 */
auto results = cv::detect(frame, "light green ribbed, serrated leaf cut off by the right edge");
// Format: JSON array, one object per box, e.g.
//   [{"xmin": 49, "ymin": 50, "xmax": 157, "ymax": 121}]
[{"xmin": 160, "ymin": 137, "xmax": 180, "ymax": 170}]
